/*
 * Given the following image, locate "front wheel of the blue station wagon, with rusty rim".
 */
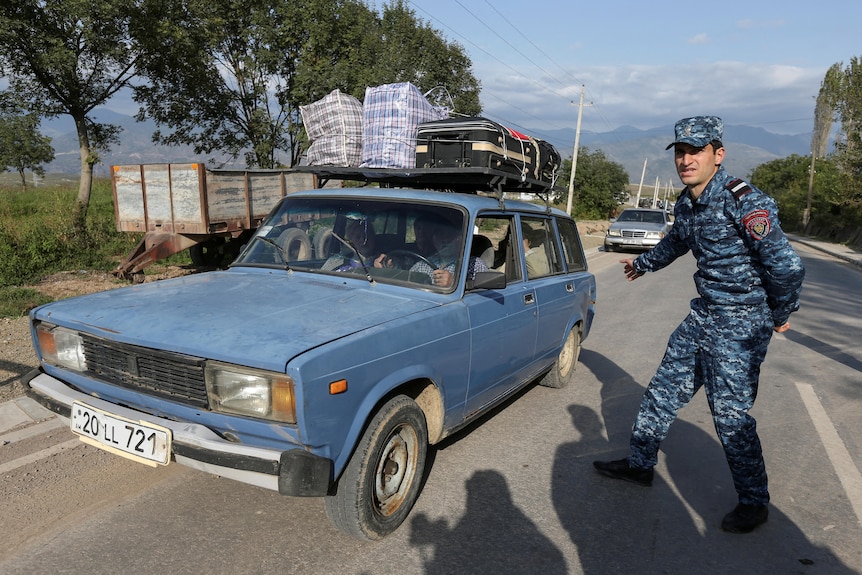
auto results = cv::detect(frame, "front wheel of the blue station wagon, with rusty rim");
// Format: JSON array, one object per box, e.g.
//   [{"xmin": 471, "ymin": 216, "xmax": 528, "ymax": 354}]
[{"xmin": 324, "ymin": 395, "xmax": 428, "ymax": 540}]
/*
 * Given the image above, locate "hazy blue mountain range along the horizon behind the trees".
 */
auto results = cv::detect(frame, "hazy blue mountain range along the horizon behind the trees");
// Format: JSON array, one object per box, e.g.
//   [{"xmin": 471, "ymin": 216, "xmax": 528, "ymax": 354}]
[{"xmin": 40, "ymin": 109, "xmax": 811, "ymax": 188}]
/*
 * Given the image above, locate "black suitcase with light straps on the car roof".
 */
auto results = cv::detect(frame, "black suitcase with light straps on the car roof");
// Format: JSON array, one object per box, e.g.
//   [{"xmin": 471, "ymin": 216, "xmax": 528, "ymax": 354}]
[{"xmin": 416, "ymin": 118, "xmax": 560, "ymax": 186}]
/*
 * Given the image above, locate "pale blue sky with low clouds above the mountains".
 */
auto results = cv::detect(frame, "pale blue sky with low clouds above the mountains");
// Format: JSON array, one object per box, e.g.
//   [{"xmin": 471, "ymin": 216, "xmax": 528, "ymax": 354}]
[{"xmin": 371, "ymin": 0, "xmax": 862, "ymax": 140}]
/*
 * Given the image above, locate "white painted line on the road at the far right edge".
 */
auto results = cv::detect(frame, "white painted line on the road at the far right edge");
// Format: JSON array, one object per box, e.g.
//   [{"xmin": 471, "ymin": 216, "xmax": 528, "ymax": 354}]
[{"xmin": 796, "ymin": 383, "xmax": 862, "ymax": 524}]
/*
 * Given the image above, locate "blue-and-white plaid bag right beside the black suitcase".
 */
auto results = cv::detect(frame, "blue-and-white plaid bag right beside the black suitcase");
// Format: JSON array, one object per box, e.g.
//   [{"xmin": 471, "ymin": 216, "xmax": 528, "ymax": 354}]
[{"xmin": 361, "ymin": 82, "xmax": 449, "ymax": 168}]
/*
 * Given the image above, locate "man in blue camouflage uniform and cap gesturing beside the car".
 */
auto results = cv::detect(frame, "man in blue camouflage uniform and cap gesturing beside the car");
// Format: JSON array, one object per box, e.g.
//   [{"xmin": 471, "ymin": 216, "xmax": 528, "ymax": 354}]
[{"xmin": 594, "ymin": 116, "xmax": 805, "ymax": 533}]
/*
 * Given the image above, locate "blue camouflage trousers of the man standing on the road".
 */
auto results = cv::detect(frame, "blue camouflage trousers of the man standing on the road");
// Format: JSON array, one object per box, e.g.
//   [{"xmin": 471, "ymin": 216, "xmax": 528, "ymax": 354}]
[{"xmin": 629, "ymin": 299, "xmax": 773, "ymax": 505}]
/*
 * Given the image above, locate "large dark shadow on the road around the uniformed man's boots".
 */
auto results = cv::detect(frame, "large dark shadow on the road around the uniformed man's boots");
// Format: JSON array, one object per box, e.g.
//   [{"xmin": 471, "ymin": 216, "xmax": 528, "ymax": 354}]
[{"xmin": 552, "ymin": 350, "xmax": 855, "ymax": 575}]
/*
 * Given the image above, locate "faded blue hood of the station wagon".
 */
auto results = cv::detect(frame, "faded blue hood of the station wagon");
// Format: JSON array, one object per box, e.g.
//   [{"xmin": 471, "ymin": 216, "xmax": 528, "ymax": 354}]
[{"xmin": 34, "ymin": 269, "xmax": 439, "ymax": 371}]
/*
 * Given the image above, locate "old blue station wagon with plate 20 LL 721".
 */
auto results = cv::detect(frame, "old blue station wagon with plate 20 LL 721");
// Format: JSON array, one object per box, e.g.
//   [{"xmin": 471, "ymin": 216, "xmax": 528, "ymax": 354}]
[{"xmin": 27, "ymin": 166, "xmax": 596, "ymax": 539}]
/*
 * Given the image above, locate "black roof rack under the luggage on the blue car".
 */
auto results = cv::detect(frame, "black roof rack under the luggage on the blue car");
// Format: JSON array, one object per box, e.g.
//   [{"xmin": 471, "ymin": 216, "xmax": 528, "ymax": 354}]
[{"xmin": 293, "ymin": 166, "xmax": 553, "ymax": 208}]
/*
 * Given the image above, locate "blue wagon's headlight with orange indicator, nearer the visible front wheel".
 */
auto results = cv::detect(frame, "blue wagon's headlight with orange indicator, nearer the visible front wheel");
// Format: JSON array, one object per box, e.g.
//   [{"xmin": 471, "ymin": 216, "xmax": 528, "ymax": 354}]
[{"xmin": 204, "ymin": 361, "xmax": 296, "ymax": 423}]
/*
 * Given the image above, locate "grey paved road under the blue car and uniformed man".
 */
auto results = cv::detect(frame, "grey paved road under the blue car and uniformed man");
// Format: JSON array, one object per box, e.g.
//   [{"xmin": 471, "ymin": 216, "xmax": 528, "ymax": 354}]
[{"xmin": 0, "ymin": 244, "xmax": 862, "ymax": 575}]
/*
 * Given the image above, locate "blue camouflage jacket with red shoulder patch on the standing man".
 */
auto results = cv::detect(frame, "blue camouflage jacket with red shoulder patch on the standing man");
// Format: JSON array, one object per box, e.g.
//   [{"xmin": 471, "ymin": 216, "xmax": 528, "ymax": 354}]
[{"xmin": 634, "ymin": 167, "xmax": 805, "ymax": 326}]
